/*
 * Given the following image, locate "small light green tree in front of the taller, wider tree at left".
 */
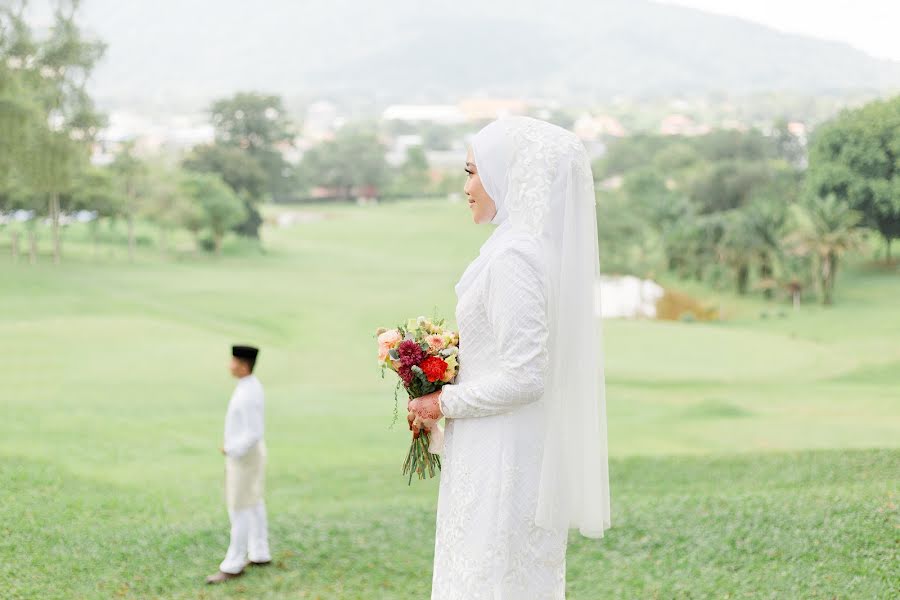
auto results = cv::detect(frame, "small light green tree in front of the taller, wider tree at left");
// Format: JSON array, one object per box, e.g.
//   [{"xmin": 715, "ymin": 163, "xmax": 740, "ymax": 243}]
[{"xmin": 182, "ymin": 173, "xmax": 247, "ymax": 254}]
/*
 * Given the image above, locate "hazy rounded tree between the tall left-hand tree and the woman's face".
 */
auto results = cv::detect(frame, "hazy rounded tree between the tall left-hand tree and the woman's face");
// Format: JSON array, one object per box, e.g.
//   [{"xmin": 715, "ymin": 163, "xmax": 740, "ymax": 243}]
[{"xmin": 302, "ymin": 127, "xmax": 387, "ymax": 199}]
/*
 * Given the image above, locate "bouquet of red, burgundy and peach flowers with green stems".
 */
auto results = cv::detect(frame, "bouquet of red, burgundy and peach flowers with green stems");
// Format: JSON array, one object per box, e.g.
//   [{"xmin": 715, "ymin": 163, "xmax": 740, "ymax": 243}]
[{"xmin": 376, "ymin": 317, "xmax": 459, "ymax": 484}]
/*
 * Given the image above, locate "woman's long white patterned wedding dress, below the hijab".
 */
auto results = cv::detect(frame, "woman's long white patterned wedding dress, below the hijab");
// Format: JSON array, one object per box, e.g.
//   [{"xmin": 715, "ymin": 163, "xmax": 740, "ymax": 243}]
[{"xmin": 432, "ymin": 232, "xmax": 568, "ymax": 600}]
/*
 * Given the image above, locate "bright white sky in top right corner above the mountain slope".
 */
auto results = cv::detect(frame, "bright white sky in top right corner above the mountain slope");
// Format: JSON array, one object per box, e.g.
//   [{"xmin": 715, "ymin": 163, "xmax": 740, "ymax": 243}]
[{"xmin": 660, "ymin": 0, "xmax": 900, "ymax": 60}]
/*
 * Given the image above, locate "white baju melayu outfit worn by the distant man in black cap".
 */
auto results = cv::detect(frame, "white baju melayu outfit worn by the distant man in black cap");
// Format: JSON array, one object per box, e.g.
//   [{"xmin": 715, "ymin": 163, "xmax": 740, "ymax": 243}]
[{"xmin": 219, "ymin": 375, "xmax": 271, "ymax": 574}]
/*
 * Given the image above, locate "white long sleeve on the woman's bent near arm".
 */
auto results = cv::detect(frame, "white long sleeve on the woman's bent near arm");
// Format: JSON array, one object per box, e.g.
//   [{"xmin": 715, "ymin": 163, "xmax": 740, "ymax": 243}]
[{"xmin": 440, "ymin": 247, "xmax": 548, "ymax": 418}]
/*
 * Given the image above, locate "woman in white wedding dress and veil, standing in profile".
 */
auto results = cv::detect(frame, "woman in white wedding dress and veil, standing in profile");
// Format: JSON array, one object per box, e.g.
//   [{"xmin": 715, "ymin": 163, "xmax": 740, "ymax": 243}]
[{"xmin": 408, "ymin": 117, "xmax": 610, "ymax": 600}]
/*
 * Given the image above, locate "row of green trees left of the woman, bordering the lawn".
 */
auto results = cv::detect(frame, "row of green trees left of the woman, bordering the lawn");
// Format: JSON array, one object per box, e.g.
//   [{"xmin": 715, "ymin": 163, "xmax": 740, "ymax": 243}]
[{"xmin": 0, "ymin": 1, "xmax": 458, "ymax": 262}]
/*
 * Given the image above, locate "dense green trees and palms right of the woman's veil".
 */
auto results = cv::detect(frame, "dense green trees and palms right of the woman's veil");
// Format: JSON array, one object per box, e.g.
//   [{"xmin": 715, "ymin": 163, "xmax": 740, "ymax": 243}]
[{"xmin": 594, "ymin": 98, "xmax": 900, "ymax": 304}]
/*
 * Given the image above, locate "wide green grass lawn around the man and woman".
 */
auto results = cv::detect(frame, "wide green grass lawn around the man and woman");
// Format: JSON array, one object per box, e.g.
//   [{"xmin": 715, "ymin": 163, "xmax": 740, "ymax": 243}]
[{"xmin": 0, "ymin": 203, "xmax": 900, "ymax": 599}]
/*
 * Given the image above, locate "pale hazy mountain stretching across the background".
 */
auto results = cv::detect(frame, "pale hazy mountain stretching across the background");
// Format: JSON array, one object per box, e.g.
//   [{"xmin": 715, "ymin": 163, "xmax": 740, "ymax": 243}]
[{"xmin": 74, "ymin": 0, "xmax": 900, "ymax": 101}]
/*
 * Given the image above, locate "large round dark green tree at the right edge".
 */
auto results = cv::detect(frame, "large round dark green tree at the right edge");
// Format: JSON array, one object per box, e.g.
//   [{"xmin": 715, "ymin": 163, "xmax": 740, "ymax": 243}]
[{"xmin": 808, "ymin": 96, "xmax": 900, "ymax": 260}]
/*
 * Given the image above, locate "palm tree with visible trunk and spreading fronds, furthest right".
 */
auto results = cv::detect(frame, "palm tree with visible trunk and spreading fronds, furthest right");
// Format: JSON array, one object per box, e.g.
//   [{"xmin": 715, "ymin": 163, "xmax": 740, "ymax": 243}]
[{"xmin": 786, "ymin": 194, "xmax": 864, "ymax": 305}]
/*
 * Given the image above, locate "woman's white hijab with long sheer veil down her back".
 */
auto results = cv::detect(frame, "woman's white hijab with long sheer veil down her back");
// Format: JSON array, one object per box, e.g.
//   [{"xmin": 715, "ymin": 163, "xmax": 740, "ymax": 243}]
[{"xmin": 456, "ymin": 117, "xmax": 610, "ymax": 538}]
